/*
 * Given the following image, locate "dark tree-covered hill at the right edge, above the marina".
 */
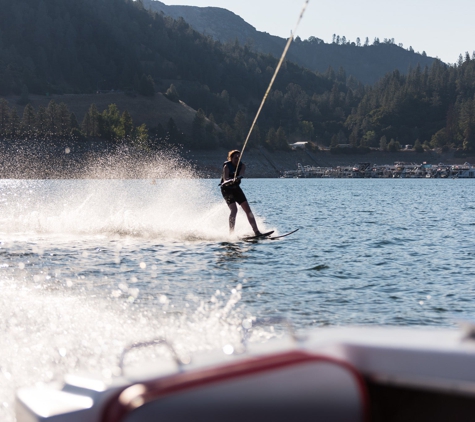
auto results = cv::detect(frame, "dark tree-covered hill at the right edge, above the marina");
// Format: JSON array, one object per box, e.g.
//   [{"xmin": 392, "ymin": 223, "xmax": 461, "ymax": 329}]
[{"xmin": 345, "ymin": 54, "xmax": 475, "ymax": 150}]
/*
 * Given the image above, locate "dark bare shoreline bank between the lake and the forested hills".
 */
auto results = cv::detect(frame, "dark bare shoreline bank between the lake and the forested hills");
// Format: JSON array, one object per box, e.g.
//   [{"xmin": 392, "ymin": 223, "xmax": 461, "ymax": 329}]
[{"xmin": 0, "ymin": 147, "xmax": 475, "ymax": 179}]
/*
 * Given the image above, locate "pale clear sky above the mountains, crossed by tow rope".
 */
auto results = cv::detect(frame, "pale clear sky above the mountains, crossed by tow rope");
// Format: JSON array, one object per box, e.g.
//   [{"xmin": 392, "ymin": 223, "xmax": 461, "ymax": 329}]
[{"xmin": 161, "ymin": 0, "xmax": 475, "ymax": 63}]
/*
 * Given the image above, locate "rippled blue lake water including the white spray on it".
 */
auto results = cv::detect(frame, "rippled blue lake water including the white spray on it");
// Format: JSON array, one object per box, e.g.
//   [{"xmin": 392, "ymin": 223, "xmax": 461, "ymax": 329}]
[{"xmin": 0, "ymin": 179, "xmax": 475, "ymax": 421}]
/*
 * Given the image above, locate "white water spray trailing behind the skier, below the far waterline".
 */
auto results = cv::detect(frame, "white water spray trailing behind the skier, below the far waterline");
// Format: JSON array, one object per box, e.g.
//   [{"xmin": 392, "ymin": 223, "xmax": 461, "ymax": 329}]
[{"xmin": 0, "ymin": 179, "xmax": 263, "ymax": 241}]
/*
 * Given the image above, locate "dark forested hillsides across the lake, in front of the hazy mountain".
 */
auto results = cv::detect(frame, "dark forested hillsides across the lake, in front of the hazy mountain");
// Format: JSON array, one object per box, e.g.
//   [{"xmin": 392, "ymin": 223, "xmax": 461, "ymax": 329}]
[{"xmin": 0, "ymin": 0, "xmax": 475, "ymax": 152}]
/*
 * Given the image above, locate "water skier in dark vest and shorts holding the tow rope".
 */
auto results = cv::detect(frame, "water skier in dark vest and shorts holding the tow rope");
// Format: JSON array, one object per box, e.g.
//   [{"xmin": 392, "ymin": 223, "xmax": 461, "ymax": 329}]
[{"xmin": 220, "ymin": 149, "xmax": 261, "ymax": 236}]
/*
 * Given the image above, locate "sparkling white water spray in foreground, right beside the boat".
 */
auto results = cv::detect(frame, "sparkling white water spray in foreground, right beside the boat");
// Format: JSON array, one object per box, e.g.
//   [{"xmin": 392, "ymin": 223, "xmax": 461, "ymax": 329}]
[{"xmin": 0, "ymin": 279, "xmax": 272, "ymax": 422}]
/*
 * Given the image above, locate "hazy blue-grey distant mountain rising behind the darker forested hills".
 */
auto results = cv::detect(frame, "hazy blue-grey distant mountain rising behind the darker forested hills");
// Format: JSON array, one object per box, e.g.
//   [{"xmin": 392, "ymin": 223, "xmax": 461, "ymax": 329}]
[{"xmin": 142, "ymin": 0, "xmax": 436, "ymax": 84}]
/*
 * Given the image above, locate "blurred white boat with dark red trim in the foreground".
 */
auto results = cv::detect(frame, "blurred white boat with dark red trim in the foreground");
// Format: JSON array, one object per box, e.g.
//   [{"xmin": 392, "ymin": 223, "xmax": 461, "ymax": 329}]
[{"xmin": 16, "ymin": 327, "xmax": 475, "ymax": 422}]
